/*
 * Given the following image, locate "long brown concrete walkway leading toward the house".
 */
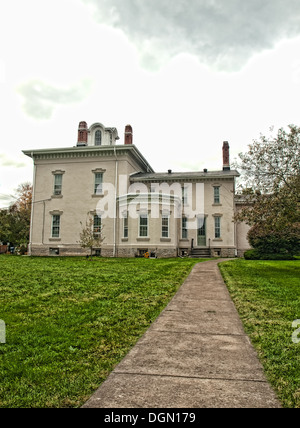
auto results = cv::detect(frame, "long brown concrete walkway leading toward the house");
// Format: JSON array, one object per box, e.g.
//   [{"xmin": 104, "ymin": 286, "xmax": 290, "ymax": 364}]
[{"xmin": 83, "ymin": 260, "xmax": 280, "ymax": 408}]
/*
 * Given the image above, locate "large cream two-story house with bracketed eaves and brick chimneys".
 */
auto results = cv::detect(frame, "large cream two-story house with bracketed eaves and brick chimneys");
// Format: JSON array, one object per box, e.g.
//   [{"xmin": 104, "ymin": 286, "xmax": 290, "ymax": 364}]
[{"xmin": 24, "ymin": 122, "xmax": 249, "ymax": 257}]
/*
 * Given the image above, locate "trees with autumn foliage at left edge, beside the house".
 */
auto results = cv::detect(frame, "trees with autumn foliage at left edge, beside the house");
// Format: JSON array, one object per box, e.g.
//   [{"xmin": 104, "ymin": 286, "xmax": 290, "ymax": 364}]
[{"xmin": 0, "ymin": 183, "xmax": 32, "ymax": 252}]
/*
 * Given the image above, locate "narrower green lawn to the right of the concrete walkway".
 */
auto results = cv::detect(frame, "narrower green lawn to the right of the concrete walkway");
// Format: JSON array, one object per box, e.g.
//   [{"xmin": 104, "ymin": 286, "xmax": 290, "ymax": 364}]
[{"xmin": 220, "ymin": 260, "xmax": 300, "ymax": 408}]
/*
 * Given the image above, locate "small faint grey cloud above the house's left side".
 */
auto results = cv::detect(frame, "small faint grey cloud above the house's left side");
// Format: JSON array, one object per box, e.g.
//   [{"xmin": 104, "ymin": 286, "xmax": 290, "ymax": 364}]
[{"xmin": 17, "ymin": 79, "xmax": 92, "ymax": 119}]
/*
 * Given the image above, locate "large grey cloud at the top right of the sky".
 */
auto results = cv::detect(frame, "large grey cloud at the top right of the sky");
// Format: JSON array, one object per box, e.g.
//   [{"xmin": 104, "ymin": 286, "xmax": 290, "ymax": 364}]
[{"xmin": 82, "ymin": 0, "xmax": 300, "ymax": 70}]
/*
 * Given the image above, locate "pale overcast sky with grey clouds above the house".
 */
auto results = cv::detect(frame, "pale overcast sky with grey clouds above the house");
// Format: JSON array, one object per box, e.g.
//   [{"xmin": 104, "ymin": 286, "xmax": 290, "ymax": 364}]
[{"xmin": 0, "ymin": 0, "xmax": 300, "ymax": 208}]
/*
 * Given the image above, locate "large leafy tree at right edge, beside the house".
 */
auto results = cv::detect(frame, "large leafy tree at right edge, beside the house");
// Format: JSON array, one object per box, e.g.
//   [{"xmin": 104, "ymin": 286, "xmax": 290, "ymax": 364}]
[{"xmin": 235, "ymin": 125, "xmax": 300, "ymax": 253}]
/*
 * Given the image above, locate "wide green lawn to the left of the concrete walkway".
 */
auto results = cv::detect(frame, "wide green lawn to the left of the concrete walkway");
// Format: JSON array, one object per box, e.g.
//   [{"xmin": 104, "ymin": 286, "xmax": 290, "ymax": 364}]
[{"xmin": 0, "ymin": 256, "xmax": 206, "ymax": 408}]
